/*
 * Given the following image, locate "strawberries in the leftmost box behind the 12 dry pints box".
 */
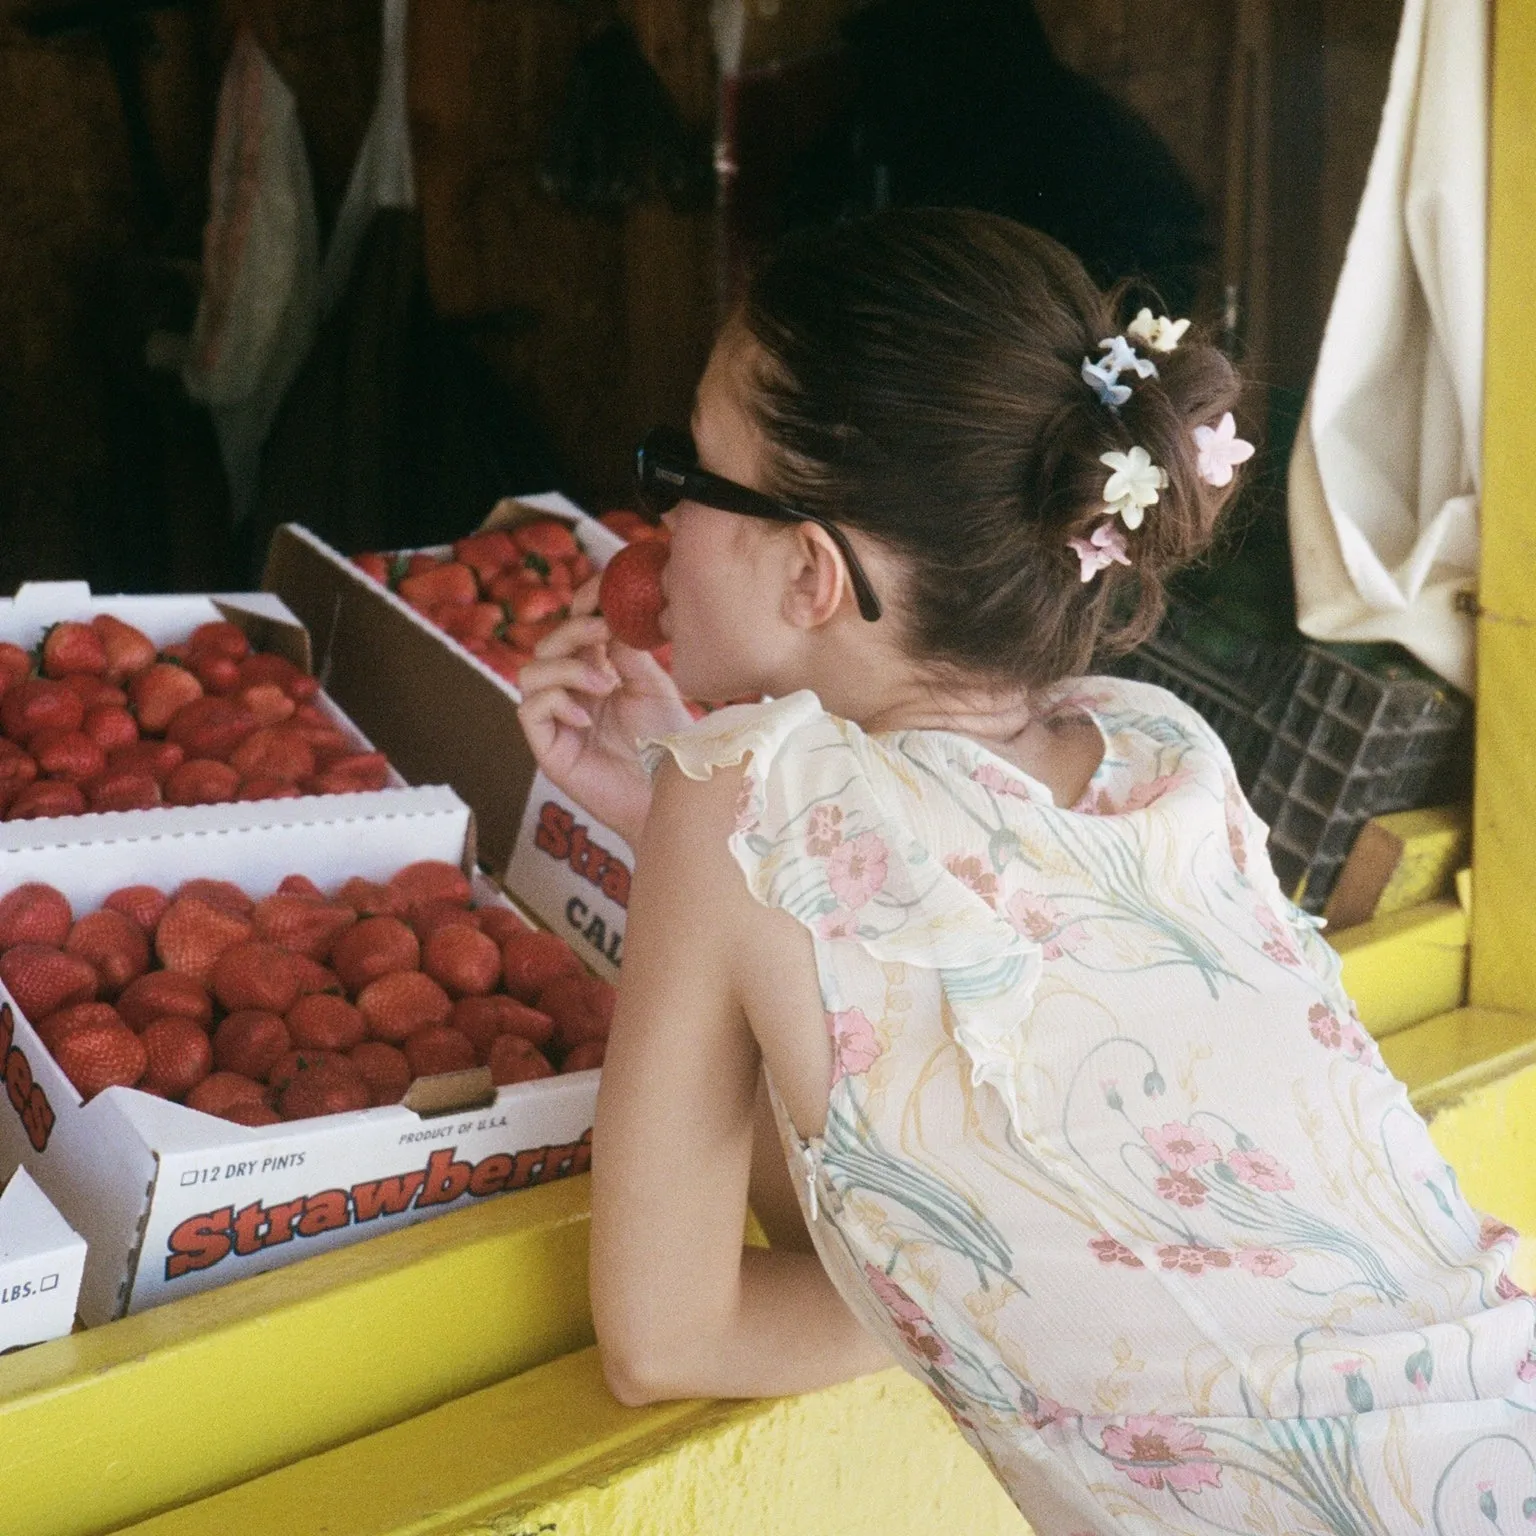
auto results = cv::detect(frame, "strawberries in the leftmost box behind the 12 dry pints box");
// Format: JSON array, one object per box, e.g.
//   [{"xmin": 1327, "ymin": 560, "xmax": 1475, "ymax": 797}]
[{"xmin": 0, "ymin": 613, "xmax": 389, "ymax": 820}]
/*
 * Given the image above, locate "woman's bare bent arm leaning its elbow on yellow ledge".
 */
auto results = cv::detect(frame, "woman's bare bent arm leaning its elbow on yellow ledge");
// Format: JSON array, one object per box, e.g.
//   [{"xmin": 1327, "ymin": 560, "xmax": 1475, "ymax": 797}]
[{"xmin": 591, "ymin": 765, "xmax": 889, "ymax": 1404}]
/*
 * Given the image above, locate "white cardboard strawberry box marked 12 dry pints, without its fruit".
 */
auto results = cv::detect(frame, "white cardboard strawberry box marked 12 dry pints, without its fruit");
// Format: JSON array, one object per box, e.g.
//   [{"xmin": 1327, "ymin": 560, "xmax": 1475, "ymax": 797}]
[{"xmin": 0, "ymin": 788, "xmax": 598, "ymax": 1324}]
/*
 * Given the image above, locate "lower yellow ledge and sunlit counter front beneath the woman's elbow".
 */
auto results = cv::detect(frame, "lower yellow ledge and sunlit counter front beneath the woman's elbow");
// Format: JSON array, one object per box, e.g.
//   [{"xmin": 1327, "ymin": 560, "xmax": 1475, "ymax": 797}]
[{"xmin": 121, "ymin": 1350, "xmax": 1029, "ymax": 1536}]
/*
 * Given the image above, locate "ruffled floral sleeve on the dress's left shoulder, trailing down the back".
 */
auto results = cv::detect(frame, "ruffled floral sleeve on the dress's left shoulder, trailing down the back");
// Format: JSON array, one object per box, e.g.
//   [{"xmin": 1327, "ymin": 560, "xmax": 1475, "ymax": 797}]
[{"xmin": 642, "ymin": 691, "xmax": 1043, "ymax": 1129}]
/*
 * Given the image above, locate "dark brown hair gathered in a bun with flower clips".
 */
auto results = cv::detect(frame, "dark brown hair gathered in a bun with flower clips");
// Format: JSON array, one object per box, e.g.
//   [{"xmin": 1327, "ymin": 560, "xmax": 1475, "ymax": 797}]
[{"xmin": 739, "ymin": 209, "xmax": 1238, "ymax": 687}]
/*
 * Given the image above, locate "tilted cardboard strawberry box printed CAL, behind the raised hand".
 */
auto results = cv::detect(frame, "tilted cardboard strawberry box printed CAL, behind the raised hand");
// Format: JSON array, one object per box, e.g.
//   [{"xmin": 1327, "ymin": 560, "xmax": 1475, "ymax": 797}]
[{"xmin": 263, "ymin": 495, "xmax": 634, "ymax": 977}]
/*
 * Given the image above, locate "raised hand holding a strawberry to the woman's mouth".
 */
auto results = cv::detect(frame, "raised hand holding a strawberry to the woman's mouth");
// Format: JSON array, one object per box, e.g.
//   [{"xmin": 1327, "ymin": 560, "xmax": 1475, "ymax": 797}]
[{"xmin": 518, "ymin": 578, "xmax": 693, "ymax": 846}]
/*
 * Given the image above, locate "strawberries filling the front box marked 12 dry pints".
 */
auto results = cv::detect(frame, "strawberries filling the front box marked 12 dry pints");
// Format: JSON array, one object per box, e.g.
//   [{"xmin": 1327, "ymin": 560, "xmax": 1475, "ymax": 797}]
[{"xmin": 0, "ymin": 860, "xmax": 613, "ymax": 1126}]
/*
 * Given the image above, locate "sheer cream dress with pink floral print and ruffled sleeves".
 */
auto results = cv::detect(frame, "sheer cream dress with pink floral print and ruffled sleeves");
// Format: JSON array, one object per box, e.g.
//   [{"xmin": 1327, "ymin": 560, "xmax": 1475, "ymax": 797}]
[{"xmin": 648, "ymin": 679, "xmax": 1536, "ymax": 1536}]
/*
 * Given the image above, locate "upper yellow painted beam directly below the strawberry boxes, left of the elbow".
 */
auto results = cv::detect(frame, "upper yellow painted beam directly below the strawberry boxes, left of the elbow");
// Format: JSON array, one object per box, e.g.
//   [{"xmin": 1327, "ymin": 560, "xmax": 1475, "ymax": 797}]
[{"xmin": 0, "ymin": 1177, "xmax": 593, "ymax": 1536}]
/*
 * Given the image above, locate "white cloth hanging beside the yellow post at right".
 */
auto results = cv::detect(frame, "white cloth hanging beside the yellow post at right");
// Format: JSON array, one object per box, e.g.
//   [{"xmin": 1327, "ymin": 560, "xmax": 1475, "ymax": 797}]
[{"xmin": 1289, "ymin": 0, "xmax": 1491, "ymax": 693}]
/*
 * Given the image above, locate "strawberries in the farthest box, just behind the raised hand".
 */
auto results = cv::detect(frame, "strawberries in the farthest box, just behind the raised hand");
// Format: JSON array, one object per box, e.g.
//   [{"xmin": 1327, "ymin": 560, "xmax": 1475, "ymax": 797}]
[{"xmin": 353, "ymin": 511, "xmax": 667, "ymax": 684}]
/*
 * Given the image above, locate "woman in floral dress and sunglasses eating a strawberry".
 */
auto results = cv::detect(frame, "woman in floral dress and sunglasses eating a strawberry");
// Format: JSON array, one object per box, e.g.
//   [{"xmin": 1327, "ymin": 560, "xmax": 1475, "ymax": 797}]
[{"xmin": 522, "ymin": 212, "xmax": 1536, "ymax": 1536}]
